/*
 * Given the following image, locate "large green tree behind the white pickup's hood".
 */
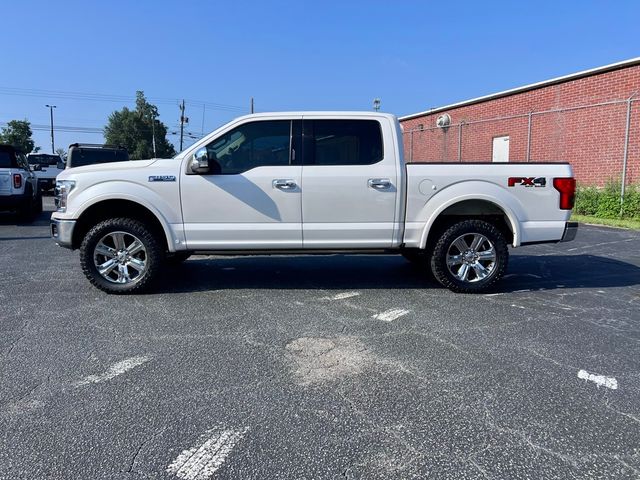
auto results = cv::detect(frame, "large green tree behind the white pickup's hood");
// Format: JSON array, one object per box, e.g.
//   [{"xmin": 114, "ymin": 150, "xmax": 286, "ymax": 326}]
[{"xmin": 104, "ymin": 91, "xmax": 176, "ymax": 160}]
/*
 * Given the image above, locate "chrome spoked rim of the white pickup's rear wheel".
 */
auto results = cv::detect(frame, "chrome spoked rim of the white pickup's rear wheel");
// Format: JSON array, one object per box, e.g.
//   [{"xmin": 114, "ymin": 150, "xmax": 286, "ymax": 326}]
[{"xmin": 447, "ymin": 233, "xmax": 496, "ymax": 283}]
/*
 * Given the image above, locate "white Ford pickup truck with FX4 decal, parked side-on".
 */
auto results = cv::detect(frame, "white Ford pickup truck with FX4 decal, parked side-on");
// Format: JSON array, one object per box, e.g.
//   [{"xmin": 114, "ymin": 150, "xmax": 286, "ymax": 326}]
[{"xmin": 51, "ymin": 112, "xmax": 577, "ymax": 293}]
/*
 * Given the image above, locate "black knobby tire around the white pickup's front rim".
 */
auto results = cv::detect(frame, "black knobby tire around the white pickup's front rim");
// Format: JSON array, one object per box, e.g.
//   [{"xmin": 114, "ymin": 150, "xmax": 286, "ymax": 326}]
[{"xmin": 80, "ymin": 218, "xmax": 165, "ymax": 294}]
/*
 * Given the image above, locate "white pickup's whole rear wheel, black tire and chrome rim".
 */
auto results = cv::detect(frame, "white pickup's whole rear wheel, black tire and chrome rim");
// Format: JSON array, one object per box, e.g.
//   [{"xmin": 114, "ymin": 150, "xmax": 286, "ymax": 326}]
[{"xmin": 431, "ymin": 220, "xmax": 509, "ymax": 293}]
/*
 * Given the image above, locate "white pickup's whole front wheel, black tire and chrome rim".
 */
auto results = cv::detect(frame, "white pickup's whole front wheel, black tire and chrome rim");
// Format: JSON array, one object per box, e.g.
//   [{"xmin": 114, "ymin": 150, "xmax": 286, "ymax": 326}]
[{"xmin": 80, "ymin": 218, "xmax": 164, "ymax": 293}]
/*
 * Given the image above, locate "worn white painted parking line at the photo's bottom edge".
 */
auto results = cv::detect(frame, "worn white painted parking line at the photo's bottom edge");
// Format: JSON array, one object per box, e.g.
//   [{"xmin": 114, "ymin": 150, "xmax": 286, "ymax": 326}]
[{"xmin": 167, "ymin": 428, "xmax": 248, "ymax": 480}]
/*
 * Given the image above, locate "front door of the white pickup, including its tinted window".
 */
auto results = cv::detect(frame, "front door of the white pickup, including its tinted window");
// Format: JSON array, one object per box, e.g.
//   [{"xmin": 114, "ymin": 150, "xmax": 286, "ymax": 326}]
[{"xmin": 180, "ymin": 119, "xmax": 302, "ymax": 250}]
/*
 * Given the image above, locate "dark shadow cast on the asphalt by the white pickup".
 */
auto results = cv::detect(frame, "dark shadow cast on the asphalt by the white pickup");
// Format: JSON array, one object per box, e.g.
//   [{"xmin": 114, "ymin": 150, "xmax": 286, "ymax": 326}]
[{"xmin": 156, "ymin": 255, "xmax": 640, "ymax": 293}]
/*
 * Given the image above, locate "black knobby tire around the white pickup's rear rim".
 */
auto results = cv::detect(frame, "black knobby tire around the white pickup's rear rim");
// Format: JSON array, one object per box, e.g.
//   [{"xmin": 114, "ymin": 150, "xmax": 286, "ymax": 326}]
[{"xmin": 431, "ymin": 220, "xmax": 509, "ymax": 293}]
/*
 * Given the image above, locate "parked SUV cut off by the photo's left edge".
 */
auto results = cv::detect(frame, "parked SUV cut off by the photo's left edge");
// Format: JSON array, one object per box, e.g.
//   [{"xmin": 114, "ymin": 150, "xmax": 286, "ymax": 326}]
[{"xmin": 0, "ymin": 145, "xmax": 42, "ymax": 218}]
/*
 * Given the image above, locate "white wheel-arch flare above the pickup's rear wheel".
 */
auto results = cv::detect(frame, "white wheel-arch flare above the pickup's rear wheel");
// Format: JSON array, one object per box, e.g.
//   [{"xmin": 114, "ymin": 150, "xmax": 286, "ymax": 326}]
[{"xmin": 417, "ymin": 180, "xmax": 525, "ymax": 248}]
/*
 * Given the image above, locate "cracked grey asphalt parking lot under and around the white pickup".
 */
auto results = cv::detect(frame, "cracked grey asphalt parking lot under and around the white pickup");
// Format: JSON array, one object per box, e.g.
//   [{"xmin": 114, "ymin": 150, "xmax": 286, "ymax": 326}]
[{"xmin": 0, "ymin": 198, "xmax": 640, "ymax": 479}]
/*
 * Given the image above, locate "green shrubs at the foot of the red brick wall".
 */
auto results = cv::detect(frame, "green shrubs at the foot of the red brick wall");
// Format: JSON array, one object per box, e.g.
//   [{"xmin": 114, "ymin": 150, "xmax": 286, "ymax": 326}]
[{"xmin": 574, "ymin": 181, "xmax": 640, "ymax": 219}]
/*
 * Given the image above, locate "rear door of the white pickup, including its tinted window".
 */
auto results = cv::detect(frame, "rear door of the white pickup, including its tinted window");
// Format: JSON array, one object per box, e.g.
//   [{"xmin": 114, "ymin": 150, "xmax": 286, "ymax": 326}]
[{"xmin": 302, "ymin": 115, "xmax": 398, "ymax": 249}]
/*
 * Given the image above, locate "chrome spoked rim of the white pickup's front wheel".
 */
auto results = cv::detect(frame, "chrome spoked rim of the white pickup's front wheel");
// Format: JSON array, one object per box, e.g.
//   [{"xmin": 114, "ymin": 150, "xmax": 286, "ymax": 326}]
[{"xmin": 93, "ymin": 232, "xmax": 147, "ymax": 284}]
